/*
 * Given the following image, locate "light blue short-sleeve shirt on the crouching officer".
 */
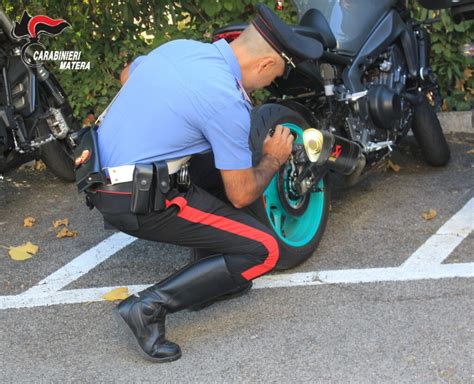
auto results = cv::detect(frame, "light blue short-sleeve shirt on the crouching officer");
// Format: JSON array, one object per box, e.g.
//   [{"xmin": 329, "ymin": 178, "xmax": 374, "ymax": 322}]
[{"xmin": 98, "ymin": 40, "xmax": 252, "ymax": 169}]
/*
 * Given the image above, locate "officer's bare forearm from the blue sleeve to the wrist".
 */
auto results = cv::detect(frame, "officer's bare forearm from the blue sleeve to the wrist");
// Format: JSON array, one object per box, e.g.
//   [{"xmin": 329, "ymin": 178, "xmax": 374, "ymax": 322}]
[{"xmin": 221, "ymin": 154, "xmax": 280, "ymax": 208}]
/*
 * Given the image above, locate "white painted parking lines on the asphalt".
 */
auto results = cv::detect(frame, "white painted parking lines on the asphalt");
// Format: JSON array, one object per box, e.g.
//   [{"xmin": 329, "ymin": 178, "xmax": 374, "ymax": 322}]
[{"xmin": 0, "ymin": 198, "xmax": 474, "ymax": 309}]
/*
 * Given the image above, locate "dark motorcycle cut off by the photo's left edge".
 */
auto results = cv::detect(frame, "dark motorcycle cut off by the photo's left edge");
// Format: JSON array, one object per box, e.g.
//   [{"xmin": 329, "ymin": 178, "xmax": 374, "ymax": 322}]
[{"xmin": 0, "ymin": 10, "xmax": 80, "ymax": 182}]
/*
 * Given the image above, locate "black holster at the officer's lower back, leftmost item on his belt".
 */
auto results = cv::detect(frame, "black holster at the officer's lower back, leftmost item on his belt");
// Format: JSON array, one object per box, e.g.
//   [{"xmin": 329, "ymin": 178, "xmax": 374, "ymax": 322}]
[{"xmin": 74, "ymin": 127, "xmax": 107, "ymax": 192}]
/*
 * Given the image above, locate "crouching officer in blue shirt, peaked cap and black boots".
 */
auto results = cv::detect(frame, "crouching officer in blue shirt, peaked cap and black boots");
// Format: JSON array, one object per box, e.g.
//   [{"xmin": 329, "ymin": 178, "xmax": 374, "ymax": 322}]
[{"xmin": 79, "ymin": 5, "xmax": 322, "ymax": 362}]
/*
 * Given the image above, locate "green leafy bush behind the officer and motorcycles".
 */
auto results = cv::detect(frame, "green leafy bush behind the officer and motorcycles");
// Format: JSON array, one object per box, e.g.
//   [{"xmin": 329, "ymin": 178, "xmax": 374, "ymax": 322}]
[{"xmin": 1, "ymin": 0, "xmax": 474, "ymax": 117}]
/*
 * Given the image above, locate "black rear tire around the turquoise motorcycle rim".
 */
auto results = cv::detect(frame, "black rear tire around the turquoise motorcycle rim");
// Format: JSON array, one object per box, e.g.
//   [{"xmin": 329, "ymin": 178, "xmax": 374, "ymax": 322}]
[{"xmin": 244, "ymin": 104, "xmax": 330, "ymax": 270}]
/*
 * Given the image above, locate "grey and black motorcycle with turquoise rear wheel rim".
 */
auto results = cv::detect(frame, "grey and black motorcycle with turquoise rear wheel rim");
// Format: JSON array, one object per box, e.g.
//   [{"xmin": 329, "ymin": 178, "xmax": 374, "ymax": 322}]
[{"xmin": 213, "ymin": 0, "xmax": 474, "ymax": 270}]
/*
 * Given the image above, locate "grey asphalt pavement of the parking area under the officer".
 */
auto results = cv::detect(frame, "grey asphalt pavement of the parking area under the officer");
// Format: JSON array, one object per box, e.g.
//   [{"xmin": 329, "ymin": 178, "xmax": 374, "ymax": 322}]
[{"xmin": 0, "ymin": 133, "xmax": 474, "ymax": 383}]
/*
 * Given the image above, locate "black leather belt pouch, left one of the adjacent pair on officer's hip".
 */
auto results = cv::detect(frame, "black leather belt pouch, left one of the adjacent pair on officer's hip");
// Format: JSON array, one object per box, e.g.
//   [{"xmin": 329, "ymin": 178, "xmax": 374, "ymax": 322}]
[{"xmin": 130, "ymin": 164, "xmax": 154, "ymax": 214}]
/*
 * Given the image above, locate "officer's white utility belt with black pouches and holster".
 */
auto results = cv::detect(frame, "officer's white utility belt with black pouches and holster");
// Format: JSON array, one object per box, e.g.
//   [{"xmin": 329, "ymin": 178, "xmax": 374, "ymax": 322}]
[{"xmin": 74, "ymin": 128, "xmax": 190, "ymax": 214}]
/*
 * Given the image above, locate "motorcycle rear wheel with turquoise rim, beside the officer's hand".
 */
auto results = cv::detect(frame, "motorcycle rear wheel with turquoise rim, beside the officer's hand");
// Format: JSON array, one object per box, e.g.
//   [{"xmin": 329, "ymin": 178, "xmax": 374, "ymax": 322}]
[{"xmin": 248, "ymin": 104, "xmax": 330, "ymax": 270}]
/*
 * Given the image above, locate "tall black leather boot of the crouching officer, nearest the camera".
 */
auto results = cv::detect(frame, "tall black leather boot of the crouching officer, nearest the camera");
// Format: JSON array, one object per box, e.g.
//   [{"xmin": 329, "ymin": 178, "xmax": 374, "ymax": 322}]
[{"xmin": 116, "ymin": 255, "xmax": 243, "ymax": 362}]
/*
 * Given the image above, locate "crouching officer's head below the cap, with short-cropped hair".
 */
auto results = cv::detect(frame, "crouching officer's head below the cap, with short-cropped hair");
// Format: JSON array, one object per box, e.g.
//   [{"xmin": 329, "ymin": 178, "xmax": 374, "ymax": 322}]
[{"xmin": 231, "ymin": 25, "xmax": 286, "ymax": 92}]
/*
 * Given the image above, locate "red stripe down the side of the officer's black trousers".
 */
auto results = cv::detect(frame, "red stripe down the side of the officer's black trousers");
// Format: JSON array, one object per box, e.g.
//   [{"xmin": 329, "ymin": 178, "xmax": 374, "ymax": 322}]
[{"xmin": 166, "ymin": 197, "xmax": 280, "ymax": 280}]
